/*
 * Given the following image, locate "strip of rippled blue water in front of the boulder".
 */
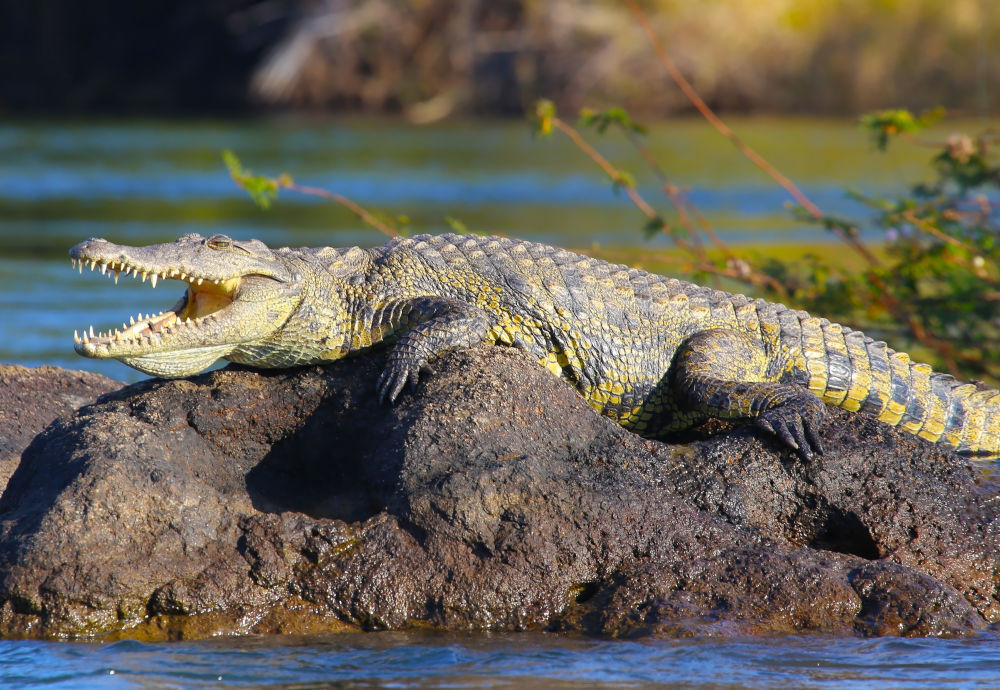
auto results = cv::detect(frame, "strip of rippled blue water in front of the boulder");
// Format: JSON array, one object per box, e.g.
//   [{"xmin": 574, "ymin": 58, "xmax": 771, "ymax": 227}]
[{"xmin": 0, "ymin": 633, "xmax": 1000, "ymax": 690}]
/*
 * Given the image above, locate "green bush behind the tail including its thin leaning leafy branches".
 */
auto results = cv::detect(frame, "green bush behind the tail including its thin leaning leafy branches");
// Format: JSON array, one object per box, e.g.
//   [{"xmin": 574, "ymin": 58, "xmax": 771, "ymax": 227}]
[{"xmin": 536, "ymin": 101, "xmax": 1000, "ymax": 383}]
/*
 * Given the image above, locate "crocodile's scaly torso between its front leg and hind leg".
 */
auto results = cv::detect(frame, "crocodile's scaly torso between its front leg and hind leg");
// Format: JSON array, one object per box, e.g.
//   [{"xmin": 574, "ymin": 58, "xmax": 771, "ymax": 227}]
[{"xmin": 375, "ymin": 235, "xmax": 752, "ymax": 435}]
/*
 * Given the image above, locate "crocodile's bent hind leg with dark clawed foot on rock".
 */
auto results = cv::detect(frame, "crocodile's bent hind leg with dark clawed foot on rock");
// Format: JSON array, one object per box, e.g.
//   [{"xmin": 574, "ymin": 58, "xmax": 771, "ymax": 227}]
[{"xmin": 673, "ymin": 328, "xmax": 826, "ymax": 459}]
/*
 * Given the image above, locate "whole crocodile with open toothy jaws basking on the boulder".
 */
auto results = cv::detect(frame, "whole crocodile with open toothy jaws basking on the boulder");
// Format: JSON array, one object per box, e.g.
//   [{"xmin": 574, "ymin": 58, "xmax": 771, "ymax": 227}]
[{"xmin": 70, "ymin": 234, "xmax": 1000, "ymax": 459}]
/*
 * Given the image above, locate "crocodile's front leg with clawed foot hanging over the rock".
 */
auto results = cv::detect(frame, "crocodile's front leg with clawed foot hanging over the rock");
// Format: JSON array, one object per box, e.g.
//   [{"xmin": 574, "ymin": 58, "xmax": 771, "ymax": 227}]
[{"xmin": 373, "ymin": 296, "xmax": 492, "ymax": 402}]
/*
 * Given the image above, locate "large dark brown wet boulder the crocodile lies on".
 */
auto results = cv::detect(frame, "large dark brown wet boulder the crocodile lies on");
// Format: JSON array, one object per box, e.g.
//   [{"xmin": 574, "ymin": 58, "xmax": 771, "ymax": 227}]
[{"xmin": 0, "ymin": 347, "xmax": 1000, "ymax": 639}]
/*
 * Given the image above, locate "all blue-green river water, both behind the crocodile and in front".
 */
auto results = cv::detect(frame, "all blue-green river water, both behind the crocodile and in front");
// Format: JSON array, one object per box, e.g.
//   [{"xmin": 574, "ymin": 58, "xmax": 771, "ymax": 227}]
[{"xmin": 0, "ymin": 120, "xmax": 1000, "ymax": 688}]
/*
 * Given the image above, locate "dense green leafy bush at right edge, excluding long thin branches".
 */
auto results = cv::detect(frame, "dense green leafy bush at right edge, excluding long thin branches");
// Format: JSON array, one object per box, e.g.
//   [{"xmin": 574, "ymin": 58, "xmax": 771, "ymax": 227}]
[{"xmin": 776, "ymin": 111, "xmax": 1000, "ymax": 383}]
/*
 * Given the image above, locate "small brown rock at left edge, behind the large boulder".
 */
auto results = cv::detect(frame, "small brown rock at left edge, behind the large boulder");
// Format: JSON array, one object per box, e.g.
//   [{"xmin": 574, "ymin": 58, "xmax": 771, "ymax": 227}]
[{"xmin": 0, "ymin": 364, "xmax": 122, "ymax": 493}]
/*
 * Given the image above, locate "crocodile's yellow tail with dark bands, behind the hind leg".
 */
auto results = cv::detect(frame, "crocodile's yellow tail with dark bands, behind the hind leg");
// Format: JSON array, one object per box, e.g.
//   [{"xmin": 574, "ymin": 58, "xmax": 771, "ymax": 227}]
[{"xmin": 778, "ymin": 310, "xmax": 1000, "ymax": 459}]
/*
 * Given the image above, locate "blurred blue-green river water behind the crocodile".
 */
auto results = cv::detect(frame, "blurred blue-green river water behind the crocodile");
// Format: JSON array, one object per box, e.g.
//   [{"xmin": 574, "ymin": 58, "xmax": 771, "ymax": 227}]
[{"xmin": 0, "ymin": 119, "xmax": 952, "ymax": 380}]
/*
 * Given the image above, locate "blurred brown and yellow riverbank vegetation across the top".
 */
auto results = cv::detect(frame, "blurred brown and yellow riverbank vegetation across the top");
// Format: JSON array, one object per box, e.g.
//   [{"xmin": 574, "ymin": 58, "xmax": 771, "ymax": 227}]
[{"xmin": 0, "ymin": 0, "xmax": 1000, "ymax": 117}]
